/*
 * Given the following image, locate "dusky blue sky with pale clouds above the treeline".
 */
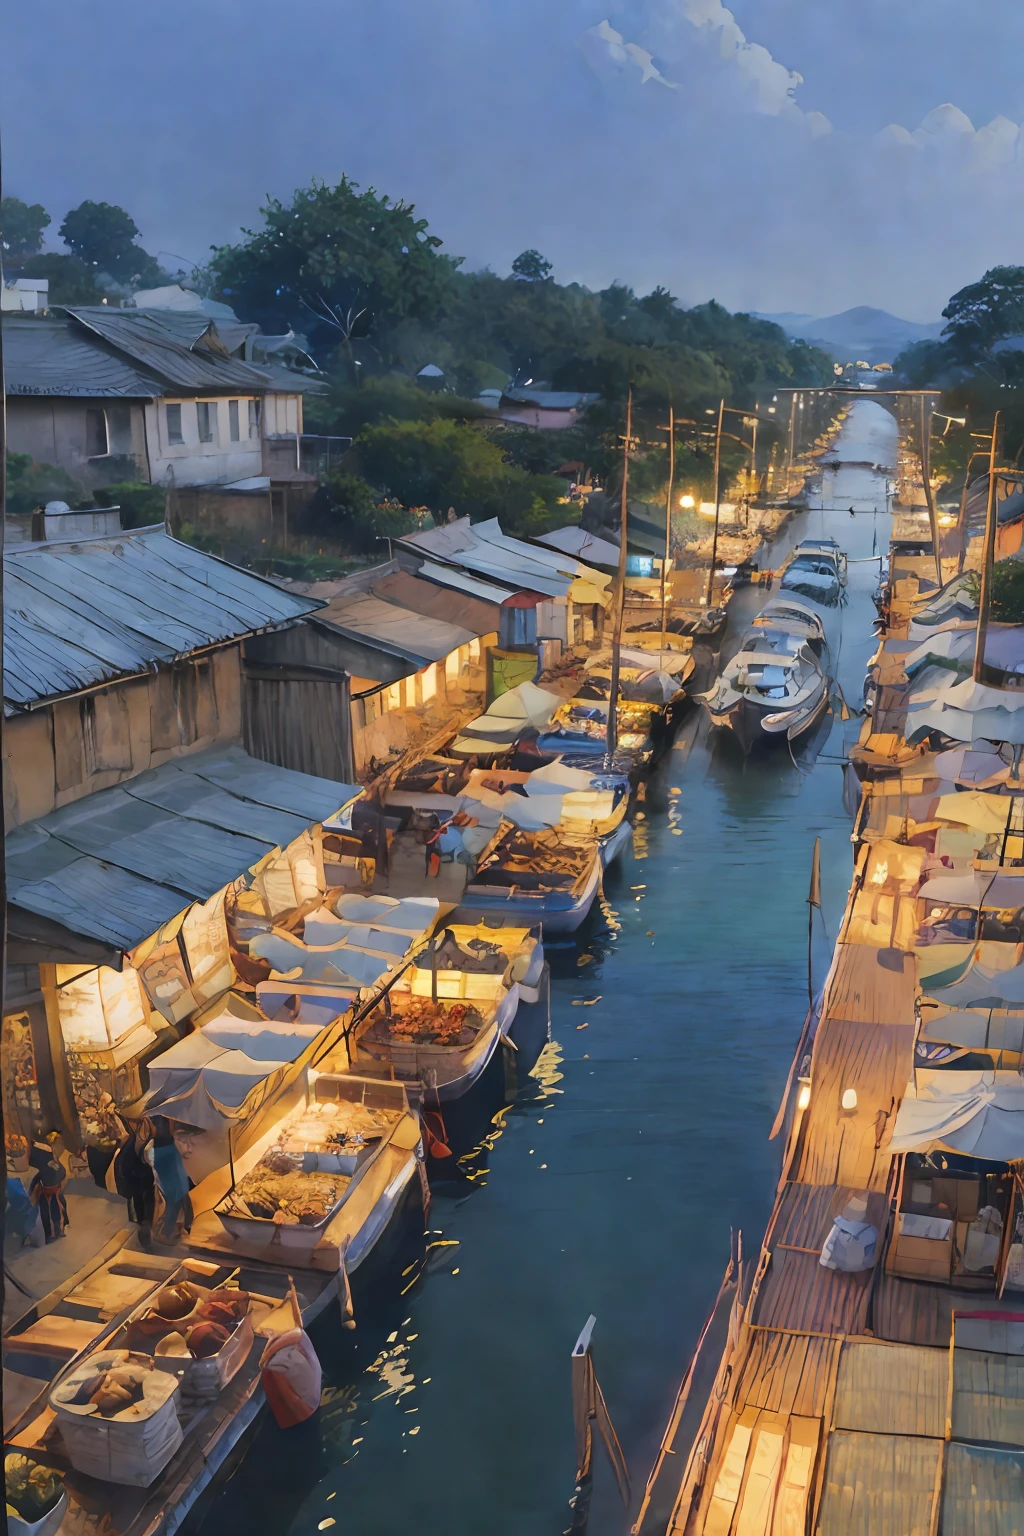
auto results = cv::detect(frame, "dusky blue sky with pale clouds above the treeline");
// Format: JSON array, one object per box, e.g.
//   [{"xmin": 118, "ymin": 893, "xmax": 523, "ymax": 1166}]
[{"xmin": 0, "ymin": 0, "xmax": 1024, "ymax": 321}]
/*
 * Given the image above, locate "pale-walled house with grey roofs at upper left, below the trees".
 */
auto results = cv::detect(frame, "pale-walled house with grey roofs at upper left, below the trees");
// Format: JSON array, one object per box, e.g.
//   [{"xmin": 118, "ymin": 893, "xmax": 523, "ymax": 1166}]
[{"xmin": 3, "ymin": 304, "xmax": 319, "ymax": 488}]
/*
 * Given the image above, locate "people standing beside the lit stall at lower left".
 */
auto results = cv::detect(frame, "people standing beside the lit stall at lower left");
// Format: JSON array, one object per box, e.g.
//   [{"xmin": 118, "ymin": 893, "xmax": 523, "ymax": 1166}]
[{"xmin": 6, "ymin": 1115, "xmax": 192, "ymax": 1247}]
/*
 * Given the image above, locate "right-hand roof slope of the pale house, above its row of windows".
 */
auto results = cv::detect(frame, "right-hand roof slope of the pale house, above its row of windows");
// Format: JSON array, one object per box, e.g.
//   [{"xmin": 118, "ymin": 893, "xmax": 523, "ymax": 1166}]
[{"xmin": 68, "ymin": 304, "xmax": 267, "ymax": 392}]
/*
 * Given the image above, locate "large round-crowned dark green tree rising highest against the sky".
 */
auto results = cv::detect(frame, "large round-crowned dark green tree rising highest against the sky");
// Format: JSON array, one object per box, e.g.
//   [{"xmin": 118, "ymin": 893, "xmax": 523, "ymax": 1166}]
[{"xmin": 209, "ymin": 177, "xmax": 459, "ymax": 364}]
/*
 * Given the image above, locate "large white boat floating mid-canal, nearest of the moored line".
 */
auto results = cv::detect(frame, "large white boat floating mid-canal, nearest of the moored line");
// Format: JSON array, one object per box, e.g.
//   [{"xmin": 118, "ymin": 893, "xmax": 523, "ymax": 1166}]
[{"xmin": 699, "ymin": 599, "xmax": 829, "ymax": 753}]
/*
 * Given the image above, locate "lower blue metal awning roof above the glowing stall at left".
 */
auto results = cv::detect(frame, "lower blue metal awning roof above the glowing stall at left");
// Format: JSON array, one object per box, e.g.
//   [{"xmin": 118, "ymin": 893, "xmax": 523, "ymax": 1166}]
[{"xmin": 6, "ymin": 746, "xmax": 362, "ymax": 949}]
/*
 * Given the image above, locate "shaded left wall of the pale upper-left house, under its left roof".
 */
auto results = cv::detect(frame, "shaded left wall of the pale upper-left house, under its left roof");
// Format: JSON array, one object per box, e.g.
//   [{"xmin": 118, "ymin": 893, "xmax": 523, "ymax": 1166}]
[{"xmin": 8, "ymin": 395, "xmax": 150, "ymax": 488}]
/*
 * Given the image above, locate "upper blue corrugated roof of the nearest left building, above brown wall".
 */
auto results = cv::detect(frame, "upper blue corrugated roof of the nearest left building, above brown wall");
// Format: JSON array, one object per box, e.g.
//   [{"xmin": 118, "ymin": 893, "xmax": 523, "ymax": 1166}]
[{"xmin": 3, "ymin": 528, "xmax": 319, "ymax": 711}]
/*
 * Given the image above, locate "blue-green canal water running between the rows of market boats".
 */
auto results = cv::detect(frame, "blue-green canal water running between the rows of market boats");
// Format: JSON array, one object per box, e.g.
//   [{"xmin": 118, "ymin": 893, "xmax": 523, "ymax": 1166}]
[{"xmin": 190, "ymin": 399, "xmax": 895, "ymax": 1536}]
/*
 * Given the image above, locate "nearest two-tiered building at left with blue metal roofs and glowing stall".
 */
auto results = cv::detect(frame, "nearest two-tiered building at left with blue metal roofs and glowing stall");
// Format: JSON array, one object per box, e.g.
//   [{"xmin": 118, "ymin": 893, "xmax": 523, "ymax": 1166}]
[{"xmin": 2, "ymin": 516, "xmax": 373, "ymax": 1147}]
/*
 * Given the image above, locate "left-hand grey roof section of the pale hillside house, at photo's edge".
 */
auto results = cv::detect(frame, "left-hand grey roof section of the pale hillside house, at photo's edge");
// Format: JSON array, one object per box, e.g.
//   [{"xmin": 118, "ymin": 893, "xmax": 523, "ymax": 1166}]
[{"xmin": 3, "ymin": 315, "xmax": 163, "ymax": 399}]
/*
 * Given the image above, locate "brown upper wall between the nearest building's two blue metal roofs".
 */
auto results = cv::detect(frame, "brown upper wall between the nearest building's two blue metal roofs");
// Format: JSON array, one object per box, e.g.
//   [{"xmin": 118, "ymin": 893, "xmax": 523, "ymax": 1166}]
[{"xmin": 3, "ymin": 645, "xmax": 241, "ymax": 831}]
